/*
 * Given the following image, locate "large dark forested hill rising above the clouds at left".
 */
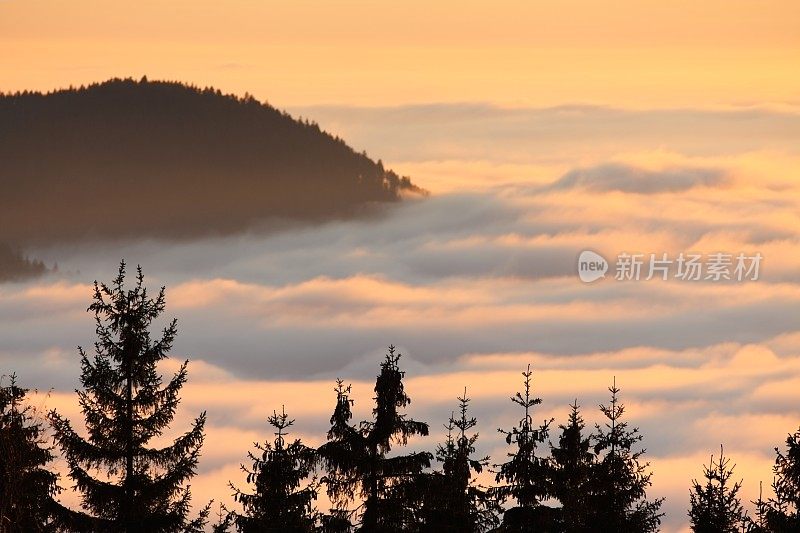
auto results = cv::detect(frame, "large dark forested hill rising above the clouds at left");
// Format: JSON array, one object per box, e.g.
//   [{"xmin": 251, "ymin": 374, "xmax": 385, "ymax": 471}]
[{"xmin": 0, "ymin": 79, "xmax": 418, "ymax": 248}]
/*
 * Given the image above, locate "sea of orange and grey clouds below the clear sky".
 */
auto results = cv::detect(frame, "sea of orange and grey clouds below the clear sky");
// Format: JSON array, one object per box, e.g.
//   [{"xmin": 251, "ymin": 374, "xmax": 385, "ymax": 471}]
[{"xmin": 0, "ymin": 102, "xmax": 800, "ymax": 531}]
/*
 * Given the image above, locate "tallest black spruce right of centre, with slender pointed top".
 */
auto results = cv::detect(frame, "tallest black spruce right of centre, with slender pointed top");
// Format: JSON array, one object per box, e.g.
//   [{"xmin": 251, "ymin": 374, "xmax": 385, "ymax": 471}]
[{"xmin": 493, "ymin": 365, "xmax": 552, "ymax": 531}]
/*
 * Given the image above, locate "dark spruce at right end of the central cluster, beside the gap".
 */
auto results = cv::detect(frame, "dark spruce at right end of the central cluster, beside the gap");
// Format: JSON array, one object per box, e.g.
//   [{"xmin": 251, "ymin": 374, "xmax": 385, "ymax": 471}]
[{"xmin": 588, "ymin": 380, "xmax": 663, "ymax": 533}]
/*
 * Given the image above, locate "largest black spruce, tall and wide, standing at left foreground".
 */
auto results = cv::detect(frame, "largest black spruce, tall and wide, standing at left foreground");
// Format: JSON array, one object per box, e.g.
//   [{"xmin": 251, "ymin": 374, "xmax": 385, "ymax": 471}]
[{"xmin": 51, "ymin": 261, "xmax": 209, "ymax": 532}]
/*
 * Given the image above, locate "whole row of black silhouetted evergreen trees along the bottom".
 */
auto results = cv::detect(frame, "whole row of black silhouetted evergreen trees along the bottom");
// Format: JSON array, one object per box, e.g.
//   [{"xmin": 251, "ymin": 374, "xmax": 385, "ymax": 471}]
[{"xmin": 0, "ymin": 262, "xmax": 800, "ymax": 533}]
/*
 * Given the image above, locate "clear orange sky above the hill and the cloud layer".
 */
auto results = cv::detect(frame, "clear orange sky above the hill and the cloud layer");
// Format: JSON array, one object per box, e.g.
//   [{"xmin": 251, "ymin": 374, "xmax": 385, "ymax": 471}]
[{"xmin": 0, "ymin": 0, "xmax": 800, "ymax": 107}]
